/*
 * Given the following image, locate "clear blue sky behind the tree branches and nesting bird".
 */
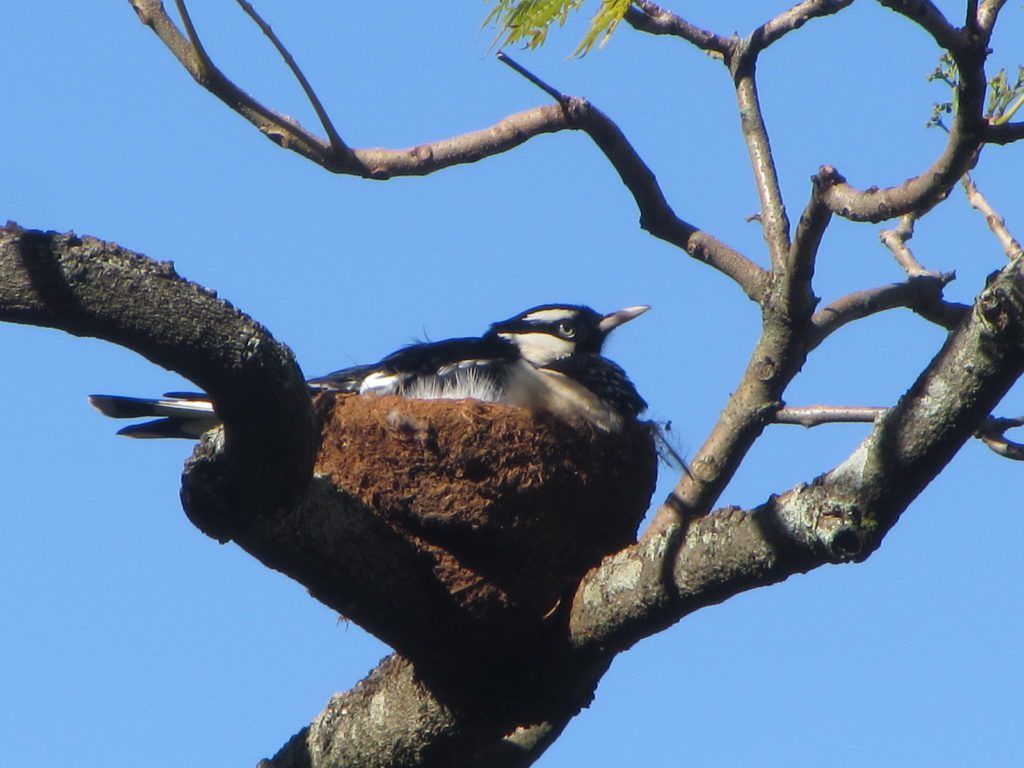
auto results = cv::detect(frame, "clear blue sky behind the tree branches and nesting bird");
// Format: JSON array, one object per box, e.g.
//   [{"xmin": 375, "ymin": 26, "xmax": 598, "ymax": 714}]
[{"xmin": 0, "ymin": 0, "xmax": 1024, "ymax": 768}]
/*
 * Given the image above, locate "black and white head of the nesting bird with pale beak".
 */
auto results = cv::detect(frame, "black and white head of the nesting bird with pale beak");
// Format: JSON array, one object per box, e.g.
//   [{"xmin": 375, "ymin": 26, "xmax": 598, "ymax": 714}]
[{"xmin": 488, "ymin": 304, "xmax": 650, "ymax": 368}]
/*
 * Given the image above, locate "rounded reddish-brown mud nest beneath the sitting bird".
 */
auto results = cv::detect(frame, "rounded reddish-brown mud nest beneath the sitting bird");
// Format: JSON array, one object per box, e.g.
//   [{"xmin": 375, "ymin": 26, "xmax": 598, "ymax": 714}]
[{"xmin": 316, "ymin": 395, "xmax": 657, "ymax": 617}]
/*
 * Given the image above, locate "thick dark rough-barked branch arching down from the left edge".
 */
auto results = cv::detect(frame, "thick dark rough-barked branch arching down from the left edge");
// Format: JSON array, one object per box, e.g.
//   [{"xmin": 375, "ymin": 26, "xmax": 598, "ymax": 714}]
[{"xmin": 0, "ymin": 223, "xmax": 317, "ymax": 520}]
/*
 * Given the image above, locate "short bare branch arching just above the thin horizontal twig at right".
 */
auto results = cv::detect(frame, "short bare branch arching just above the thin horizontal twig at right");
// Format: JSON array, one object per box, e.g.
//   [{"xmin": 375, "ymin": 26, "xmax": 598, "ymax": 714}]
[{"xmin": 808, "ymin": 272, "xmax": 968, "ymax": 342}]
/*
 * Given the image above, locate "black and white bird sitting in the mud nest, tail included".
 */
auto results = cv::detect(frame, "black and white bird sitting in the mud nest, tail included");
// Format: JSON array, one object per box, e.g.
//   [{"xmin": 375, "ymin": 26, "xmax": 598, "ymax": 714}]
[{"xmin": 89, "ymin": 304, "xmax": 650, "ymax": 438}]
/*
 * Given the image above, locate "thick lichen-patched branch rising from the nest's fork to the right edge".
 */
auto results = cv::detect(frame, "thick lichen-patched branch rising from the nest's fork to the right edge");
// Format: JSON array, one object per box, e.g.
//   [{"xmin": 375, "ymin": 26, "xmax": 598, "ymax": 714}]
[{"xmin": 569, "ymin": 260, "xmax": 1024, "ymax": 648}]
